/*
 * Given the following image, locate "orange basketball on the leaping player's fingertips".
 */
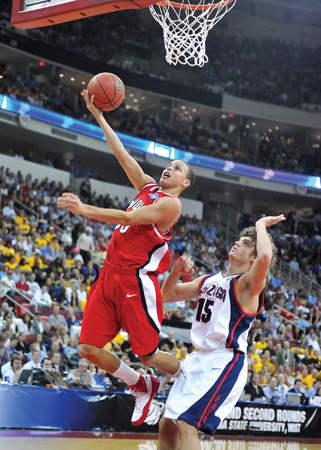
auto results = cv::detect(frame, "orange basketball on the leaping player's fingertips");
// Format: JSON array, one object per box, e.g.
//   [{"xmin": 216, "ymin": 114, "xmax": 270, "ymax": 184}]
[{"xmin": 87, "ymin": 72, "xmax": 125, "ymax": 111}]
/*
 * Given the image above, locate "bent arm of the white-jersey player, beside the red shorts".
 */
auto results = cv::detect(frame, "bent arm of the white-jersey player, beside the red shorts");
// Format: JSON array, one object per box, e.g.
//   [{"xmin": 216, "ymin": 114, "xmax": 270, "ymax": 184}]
[{"xmin": 162, "ymin": 256, "xmax": 203, "ymax": 303}]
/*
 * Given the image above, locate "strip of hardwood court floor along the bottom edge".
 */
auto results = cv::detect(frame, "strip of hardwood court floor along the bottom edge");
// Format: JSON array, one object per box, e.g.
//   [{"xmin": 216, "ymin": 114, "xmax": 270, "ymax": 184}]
[{"xmin": 0, "ymin": 430, "xmax": 321, "ymax": 450}]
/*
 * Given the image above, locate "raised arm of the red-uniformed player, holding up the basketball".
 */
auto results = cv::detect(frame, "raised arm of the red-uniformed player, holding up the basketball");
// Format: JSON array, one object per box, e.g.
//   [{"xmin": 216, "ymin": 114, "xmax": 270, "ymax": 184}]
[{"xmin": 84, "ymin": 90, "xmax": 155, "ymax": 192}]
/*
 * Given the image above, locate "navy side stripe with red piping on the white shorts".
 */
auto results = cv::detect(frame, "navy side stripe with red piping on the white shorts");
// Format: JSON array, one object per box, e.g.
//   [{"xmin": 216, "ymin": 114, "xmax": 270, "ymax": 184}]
[{"xmin": 177, "ymin": 351, "xmax": 245, "ymax": 434}]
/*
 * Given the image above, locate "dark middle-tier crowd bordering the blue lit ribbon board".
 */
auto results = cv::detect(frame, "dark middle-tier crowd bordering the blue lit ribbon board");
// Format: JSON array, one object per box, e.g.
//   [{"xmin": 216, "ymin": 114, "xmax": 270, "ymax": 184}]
[{"xmin": 0, "ymin": 64, "xmax": 321, "ymax": 180}]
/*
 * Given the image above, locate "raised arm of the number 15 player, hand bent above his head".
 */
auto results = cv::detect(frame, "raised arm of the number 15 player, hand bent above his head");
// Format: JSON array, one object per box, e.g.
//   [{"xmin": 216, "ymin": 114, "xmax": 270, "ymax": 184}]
[{"xmin": 237, "ymin": 214, "xmax": 285, "ymax": 307}]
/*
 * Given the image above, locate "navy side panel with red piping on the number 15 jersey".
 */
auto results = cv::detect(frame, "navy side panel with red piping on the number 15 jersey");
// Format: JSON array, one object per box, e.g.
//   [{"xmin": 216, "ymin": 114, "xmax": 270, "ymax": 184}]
[{"xmin": 226, "ymin": 275, "xmax": 262, "ymax": 350}]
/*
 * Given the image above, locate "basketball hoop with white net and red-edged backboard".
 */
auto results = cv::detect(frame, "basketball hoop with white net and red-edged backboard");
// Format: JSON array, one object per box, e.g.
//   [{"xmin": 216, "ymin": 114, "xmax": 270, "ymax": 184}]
[{"xmin": 11, "ymin": 0, "xmax": 236, "ymax": 67}]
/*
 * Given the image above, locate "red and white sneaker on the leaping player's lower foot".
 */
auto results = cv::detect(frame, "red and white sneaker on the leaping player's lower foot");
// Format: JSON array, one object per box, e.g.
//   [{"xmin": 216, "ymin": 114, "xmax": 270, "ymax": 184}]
[{"xmin": 128, "ymin": 375, "xmax": 159, "ymax": 427}]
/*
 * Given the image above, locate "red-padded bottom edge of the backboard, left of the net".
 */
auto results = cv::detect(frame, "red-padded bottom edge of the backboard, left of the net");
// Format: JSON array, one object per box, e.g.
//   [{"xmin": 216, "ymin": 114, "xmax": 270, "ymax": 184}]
[{"xmin": 11, "ymin": 0, "xmax": 157, "ymax": 29}]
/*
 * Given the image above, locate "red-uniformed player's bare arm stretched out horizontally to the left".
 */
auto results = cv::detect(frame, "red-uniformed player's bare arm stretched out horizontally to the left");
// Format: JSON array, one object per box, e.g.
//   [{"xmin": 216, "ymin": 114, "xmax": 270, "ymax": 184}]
[{"xmin": 57, "ymin": 192, "xmax": 181, "ymax": 231}]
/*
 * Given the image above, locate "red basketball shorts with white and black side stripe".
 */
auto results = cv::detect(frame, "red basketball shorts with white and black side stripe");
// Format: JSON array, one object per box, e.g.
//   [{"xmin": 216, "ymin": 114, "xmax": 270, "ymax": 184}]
[{"xmin": 79, "ymin": 262, "xmax": 163, "ymax": 356}]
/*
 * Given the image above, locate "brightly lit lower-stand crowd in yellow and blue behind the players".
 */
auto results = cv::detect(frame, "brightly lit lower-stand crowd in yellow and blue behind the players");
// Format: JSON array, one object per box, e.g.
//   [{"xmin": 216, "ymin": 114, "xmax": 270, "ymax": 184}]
[{"xmin": 0, "ymin": 167, "xmax": 321, "ymax": 403}]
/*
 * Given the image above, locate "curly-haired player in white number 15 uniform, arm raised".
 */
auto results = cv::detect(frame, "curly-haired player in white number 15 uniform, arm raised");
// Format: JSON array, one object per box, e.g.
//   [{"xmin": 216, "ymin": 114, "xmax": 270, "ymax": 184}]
[{"xmin": 158, "ymin": 214, "xmax": 285, "ymax": 450}]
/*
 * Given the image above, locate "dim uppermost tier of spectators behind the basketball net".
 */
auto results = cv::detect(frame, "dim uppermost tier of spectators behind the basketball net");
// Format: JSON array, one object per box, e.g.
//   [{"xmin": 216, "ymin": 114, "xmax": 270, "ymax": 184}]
[{"xmin": 2, "ymin": 3, "xmax": 321, "ymax": 111}]
